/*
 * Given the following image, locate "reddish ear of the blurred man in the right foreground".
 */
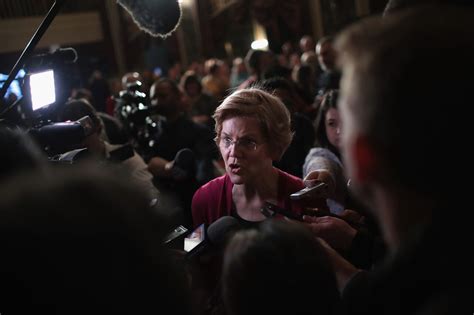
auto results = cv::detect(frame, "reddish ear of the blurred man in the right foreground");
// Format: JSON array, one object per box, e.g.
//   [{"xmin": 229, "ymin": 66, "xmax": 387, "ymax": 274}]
[{"xmin": 351, "ymin": 136, "xmax": 380, "ymax": 183}]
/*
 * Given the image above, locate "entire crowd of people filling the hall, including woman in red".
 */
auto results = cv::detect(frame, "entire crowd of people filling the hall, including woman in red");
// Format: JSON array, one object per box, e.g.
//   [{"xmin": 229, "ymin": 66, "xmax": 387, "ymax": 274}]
[{"xmin": 0, "ymin": 0, "xmax": 474, "ymax": 315}]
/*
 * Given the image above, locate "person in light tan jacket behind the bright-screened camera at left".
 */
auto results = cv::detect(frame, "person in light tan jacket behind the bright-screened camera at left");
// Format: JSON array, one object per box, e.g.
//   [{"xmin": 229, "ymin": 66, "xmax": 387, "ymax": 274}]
[{"xmin": 59, "ymin": 99, "xmax": 158, "ymax": 199}]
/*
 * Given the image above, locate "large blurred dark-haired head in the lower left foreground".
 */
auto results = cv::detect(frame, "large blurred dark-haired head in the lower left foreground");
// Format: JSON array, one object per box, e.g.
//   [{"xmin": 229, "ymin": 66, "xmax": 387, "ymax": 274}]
[{"xmin": 0, "ymin": 168, "xmax": 189, "ymax": 315}]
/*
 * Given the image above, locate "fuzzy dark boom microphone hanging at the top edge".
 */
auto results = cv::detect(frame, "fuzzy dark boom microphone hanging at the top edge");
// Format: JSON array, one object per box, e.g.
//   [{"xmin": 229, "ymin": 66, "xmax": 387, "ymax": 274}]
[{"xmin": 117, "ymin": 0, "xmax": 181, "ymax": 38}]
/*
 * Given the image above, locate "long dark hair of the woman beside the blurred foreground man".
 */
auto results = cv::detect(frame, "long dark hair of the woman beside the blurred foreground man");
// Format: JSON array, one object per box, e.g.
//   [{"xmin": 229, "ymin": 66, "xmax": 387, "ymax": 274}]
[{"xmin": 314, "ymin": 90, "xmax": 340, "ymax": 157}]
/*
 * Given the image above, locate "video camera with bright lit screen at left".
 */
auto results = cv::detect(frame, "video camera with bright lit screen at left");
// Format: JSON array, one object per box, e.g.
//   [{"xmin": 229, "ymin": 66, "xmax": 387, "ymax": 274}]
[{"xmin": 0, "ymin": 48, "xmax": 92, "ymax": 157}]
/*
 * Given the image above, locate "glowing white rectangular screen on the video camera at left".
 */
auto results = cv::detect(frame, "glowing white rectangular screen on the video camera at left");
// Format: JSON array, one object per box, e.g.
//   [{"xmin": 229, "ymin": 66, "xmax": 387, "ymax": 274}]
[{"xmin": 30, "ymin": 70, "xmax": 56, "ymax": 110}]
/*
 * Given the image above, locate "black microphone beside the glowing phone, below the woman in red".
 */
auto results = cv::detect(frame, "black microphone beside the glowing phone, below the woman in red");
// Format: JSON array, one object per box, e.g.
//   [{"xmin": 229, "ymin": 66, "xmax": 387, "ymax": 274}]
[{"xmin": 186, "ymin": 216, "xmax": 241, "ymax": 259}]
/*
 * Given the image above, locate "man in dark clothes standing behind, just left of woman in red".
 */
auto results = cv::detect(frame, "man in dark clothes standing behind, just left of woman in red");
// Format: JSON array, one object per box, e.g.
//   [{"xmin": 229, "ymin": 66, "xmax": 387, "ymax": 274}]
[{"xmin": 145, "ymin": 79, "xmax": 217, "ymax": 225}]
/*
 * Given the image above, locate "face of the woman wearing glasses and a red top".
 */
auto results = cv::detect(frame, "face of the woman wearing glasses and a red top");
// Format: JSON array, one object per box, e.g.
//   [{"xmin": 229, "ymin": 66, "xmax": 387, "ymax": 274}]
[{"xmin": 219, "ymin": 117, "xmax": 272, "ymax": 185}]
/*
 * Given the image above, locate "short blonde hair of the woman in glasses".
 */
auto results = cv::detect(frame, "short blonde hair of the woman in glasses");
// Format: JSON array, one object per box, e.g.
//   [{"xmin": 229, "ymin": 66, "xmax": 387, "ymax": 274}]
[{"xmin": 213, "ymin": 88, "xmax": 293, "ymax": 160}]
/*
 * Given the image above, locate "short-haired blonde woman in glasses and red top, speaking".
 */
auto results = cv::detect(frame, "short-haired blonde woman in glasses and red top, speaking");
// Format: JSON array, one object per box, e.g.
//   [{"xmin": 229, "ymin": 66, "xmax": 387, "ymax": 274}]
[{"xmin": 192, "ymin": 88, "xmax": 304, "ymax": 226}]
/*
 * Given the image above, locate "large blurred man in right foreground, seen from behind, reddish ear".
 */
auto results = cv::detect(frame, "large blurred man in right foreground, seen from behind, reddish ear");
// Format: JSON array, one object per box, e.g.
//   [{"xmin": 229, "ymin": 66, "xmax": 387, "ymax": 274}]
[{"xmin": 312, "ymin": 6, "xmax": 474, "ymax": 314}]
